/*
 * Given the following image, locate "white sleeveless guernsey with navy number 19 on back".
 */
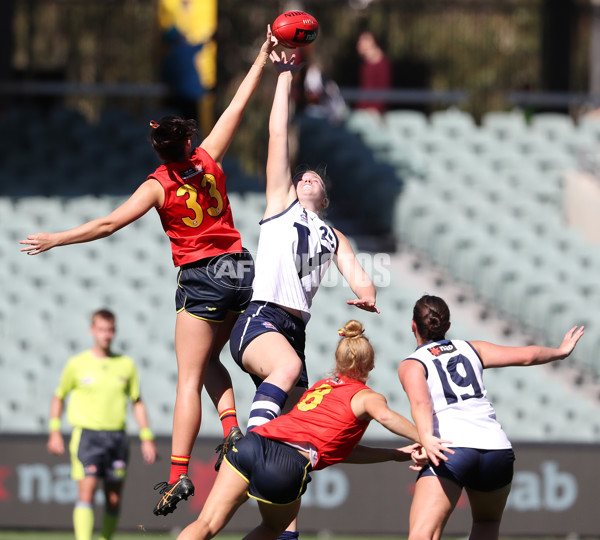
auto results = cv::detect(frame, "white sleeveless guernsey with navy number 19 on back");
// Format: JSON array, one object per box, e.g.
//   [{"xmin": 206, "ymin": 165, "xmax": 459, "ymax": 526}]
[{"xmin": 404, "ymin": 340, "xmax": 511, "ymax": 450}]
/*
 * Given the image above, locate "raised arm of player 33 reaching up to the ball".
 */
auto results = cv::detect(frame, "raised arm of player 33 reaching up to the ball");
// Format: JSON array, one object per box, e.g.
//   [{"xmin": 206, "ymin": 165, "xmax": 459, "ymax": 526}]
[{"xmin": 200, "ymin": 26, "xmax": 277, "ymax": 167}]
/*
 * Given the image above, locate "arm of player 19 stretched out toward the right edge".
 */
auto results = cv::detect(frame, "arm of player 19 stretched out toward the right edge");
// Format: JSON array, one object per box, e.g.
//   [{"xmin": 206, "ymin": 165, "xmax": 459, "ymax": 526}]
[{"xmin": 470, "ymin": 326, "xmax": 584, "ymax": 368}]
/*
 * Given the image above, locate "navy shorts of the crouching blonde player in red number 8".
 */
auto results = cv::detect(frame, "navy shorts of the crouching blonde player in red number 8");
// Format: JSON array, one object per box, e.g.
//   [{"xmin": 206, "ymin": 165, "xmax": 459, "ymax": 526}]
[{"xmin": 225, "ymin": 432, "xmax": 312, "ymax": 504}]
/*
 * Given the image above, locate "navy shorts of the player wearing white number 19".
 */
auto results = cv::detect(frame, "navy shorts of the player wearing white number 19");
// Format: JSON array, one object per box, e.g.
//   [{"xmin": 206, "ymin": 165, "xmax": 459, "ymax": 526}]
[{"xmin": 418, "ymin": 448, "xmax": 515, "ymax": 491}]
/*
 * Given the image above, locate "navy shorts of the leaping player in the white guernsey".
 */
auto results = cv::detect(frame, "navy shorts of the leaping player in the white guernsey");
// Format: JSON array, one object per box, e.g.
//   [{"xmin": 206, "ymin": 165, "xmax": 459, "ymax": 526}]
[{"xmin": 229, "ymin": 300, "xmax": 308, "ymax": 388}]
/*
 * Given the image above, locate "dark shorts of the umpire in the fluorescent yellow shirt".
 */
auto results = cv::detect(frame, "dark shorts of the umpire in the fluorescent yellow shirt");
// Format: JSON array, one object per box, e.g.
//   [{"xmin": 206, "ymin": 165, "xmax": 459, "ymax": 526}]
[{"xmin": 70, "ymin": 428, "xmax": 129, "ymax": 482}]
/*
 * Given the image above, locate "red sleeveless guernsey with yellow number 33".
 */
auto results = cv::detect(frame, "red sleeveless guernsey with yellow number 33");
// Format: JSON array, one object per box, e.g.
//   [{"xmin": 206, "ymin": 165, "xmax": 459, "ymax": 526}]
[{"xmin": 148, "ymin": 147, "xmax": 242, "ymax": 266}]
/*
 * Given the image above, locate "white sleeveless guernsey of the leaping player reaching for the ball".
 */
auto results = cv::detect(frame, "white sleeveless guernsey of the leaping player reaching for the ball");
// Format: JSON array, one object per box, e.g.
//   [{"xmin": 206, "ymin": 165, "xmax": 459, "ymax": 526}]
[{"xmin": 252, "ymin": 200, "xmax": 339, "ymax": 323}]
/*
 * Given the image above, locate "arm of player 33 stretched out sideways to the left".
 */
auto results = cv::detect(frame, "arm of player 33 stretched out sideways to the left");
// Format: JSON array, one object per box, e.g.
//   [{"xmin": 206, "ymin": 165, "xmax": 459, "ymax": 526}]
[{"xmin": 19, "ymin": 180, "xmax": 164, "ymax": 255}]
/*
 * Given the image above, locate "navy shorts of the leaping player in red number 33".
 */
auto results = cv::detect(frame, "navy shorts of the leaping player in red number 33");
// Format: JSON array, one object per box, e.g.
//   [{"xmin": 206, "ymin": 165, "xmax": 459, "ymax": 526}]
[{"xmin": 175, "ymin": 249, "xmax": 254, "ymax": 322}]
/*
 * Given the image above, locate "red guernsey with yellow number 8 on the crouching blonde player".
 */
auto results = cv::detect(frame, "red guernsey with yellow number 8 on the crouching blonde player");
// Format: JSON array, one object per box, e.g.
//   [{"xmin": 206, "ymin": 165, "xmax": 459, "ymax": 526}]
[{"xmin": 252, "ymin": 376, "xmax": 369, "ymax": 470}]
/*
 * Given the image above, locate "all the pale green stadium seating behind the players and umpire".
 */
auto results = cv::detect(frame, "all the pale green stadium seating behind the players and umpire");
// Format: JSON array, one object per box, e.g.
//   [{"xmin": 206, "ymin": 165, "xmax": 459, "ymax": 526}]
[{"xmin": 0, "ymin": 104, "xmax": 600, "ymax": 442}]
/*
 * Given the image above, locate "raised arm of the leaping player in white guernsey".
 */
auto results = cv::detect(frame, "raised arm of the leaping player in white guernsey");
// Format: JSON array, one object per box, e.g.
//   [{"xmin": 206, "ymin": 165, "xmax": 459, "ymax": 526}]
[{"xmin": 265, "ymin": 51, "xmax": 302, "ymax": 218}]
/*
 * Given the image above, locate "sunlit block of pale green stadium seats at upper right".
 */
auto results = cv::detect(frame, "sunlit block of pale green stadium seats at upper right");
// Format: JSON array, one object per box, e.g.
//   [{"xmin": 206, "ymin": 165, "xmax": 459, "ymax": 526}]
[{"xmin": 382, "ymin": 106, "xmax": 598, "ymax": 352}]
